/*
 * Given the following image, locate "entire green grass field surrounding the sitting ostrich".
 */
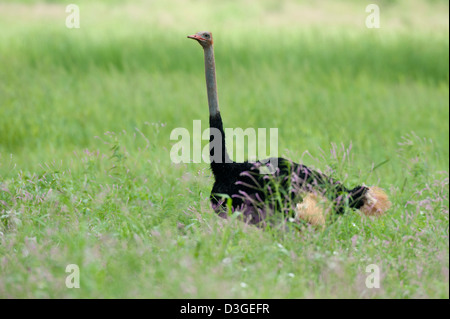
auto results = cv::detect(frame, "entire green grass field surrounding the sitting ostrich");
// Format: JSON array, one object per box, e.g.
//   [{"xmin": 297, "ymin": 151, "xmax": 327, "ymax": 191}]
[{"xmin": 0, "ymin": 0, "xmax": 449, "ymax": 298}]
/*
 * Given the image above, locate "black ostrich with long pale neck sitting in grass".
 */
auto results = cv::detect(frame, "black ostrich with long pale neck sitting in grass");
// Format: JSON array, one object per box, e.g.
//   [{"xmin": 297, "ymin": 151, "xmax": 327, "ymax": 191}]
[{"xmin": 188, "ymin": 31, "xmax": 390, "ymax": 226}]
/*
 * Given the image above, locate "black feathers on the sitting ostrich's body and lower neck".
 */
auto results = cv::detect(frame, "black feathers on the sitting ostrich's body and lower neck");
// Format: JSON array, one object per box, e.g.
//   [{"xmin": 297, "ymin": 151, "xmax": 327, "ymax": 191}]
[{"xmin": 209, "ymin": 113, "xmax": 367, "ymax": 224}]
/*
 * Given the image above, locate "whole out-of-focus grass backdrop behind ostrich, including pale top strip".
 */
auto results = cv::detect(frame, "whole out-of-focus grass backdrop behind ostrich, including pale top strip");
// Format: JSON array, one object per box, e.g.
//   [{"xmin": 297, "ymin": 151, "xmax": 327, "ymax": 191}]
[{"xmin": 0, "ymin": 1, "xmax": 448, "ymax": 178}]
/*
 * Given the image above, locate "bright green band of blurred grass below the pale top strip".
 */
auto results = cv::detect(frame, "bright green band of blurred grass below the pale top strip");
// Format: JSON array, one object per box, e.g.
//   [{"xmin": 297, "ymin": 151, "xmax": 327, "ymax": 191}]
[{"xmin": 1, "ymin": 27, "xmax": 448, "ymax": 174}]
